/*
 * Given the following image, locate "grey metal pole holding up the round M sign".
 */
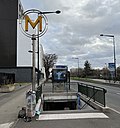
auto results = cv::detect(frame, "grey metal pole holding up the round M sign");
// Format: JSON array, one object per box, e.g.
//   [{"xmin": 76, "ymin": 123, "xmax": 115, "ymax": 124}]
[{"xmin": 32, "ymin": 34, "xmax": 36, "ymax": 91}]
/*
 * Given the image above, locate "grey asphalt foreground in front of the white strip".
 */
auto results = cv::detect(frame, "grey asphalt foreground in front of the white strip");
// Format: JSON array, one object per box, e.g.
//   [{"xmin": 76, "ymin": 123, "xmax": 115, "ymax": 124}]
[{"xmin": 12, "ymin": 107, "xmax": 120, "ymax": 128}]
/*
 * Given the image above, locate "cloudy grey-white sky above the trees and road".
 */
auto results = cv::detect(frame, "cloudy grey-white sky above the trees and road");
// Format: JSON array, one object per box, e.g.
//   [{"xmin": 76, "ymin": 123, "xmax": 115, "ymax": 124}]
[{"xmin": 21, "ymin": 0, "xmax": 120, "ymax": 68}]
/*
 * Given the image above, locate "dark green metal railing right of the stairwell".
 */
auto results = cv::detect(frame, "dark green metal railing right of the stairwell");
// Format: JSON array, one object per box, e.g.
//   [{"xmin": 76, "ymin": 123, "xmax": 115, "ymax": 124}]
[{"xmin": 78, "ymin": 83, "xmax": 107, "ymax": 107}]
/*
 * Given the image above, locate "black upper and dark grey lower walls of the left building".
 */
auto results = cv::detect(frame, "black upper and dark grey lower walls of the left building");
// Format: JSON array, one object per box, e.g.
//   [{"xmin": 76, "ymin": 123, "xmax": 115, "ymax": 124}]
[{"xmin": 0, "ymin": 0, "xmax": 43, "ymax": 82}]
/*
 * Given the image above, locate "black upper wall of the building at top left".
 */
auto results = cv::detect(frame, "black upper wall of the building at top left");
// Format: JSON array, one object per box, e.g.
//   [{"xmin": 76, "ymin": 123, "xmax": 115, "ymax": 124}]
[{"xmin": 0, "ymin": 0, "xmax": 23, "ymax": 67}]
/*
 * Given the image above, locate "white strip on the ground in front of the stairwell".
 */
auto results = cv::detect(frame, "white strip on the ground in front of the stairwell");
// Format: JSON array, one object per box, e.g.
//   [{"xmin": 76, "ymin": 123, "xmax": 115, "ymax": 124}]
[{"xmin": 38, "ymin": 113, "xmax": 109, "ymax": 120}]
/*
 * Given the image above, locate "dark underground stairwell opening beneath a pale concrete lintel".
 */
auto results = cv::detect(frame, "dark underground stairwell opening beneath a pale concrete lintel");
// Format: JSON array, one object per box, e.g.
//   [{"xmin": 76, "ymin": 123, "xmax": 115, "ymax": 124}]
[{"xmin": 42, "ymin": 92, "xmax": 93, "ymax": 111}]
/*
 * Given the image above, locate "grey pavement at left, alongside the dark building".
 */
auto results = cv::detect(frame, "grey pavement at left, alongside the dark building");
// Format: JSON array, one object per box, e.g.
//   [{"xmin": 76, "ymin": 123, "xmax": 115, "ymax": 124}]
[{"xmin": 0, "ymin": 86, "xmax": 30, "ymax": 125}]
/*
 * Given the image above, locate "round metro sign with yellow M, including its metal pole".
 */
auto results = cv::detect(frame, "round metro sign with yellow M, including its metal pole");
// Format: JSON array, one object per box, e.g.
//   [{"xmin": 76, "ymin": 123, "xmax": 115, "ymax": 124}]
[{"xmin": 20, "ymin": 9, "xmax": 48, "ymax": 91}]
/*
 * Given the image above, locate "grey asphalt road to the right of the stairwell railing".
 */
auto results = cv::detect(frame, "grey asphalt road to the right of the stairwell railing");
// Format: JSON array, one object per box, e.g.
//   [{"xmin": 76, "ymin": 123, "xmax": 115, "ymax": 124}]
[{"xmin": 71, "ymin": 81, "xmax": 120, "ymax": 113}]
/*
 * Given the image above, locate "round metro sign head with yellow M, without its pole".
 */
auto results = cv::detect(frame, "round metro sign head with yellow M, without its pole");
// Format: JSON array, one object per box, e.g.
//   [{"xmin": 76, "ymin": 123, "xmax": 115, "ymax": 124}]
[{"xmin": 21, "ymin": 9, "xmax": 48, "ymax": 38}]
